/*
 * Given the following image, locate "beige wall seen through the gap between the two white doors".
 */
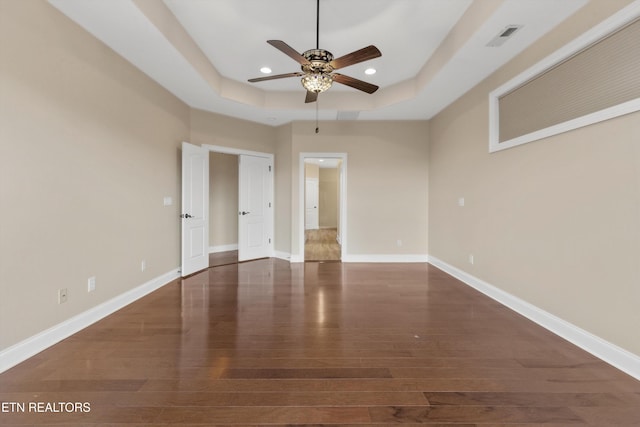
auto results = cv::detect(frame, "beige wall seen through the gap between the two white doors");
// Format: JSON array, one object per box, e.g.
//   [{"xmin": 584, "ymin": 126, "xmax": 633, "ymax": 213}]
[{"xmin": 209, "ymin": 152, "xmax": 238, "ymax": 247}]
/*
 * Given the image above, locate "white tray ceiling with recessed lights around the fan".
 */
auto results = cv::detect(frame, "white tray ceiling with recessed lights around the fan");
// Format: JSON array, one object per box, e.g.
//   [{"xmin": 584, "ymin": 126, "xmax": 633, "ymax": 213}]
[{"xmin": 49, "ymin": 0, "xmax": 588, "ymax": 126}]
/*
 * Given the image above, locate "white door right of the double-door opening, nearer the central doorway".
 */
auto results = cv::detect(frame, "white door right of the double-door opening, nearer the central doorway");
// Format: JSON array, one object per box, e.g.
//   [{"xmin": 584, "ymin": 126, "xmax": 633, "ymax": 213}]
[{"xmin": 238, "ymin": 154, "xmax": 273, "ymax": 261}]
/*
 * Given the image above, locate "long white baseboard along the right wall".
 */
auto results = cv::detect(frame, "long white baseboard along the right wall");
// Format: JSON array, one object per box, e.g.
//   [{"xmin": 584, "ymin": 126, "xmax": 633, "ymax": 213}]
[{"xmin": 429, "ymin": 256, "xmax": 640, "ymax": 380}]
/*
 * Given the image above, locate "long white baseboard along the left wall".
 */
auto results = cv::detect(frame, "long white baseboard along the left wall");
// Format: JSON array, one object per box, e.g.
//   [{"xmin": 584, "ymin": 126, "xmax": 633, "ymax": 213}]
[{"xmin": 0, "ymin": 268, "xmax": 180, "ymax": 373}]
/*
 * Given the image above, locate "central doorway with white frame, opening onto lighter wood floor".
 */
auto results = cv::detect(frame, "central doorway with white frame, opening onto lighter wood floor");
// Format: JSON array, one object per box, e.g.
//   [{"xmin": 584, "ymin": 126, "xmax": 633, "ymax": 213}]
[{"xmin": 300, "ymin": 153, "xmax": 346, "ymax": 262}]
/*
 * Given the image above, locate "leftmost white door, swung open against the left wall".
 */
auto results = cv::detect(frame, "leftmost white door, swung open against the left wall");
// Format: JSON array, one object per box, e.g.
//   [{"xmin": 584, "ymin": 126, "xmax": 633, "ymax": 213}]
[{"xmin": 180, "ymin": 142, "xmax": 209, "ymax": 277}]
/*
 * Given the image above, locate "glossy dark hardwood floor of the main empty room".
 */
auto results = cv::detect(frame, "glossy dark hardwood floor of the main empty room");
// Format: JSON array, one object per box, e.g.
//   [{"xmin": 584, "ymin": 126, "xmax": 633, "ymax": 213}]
[{"xmin": 0, "ymin": 259, "xmax": 640, "ymax": 427}]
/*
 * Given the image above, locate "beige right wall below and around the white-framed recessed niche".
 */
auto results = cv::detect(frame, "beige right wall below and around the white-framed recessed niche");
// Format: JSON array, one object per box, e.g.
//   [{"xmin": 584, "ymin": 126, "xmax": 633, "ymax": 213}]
[{"xmin": 429, "ymin": 1, "xmax": 640, "ymax": 354}]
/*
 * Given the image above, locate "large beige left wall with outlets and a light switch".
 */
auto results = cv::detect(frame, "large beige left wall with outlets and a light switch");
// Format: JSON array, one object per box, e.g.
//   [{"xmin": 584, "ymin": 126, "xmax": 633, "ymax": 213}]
[{"xmin": 0, "ymin": 1, "xmax": 189, "ymax": 350}]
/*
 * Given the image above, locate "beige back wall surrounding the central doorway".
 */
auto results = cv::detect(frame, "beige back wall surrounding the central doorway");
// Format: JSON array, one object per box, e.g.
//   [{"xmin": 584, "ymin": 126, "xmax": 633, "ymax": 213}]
[{"xmin": 291, "ymin": 121, "xmax": 428, "ymax": 255}]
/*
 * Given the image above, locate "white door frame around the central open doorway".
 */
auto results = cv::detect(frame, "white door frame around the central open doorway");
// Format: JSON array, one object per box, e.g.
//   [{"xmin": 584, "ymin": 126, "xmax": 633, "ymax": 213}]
[{"xmin": 298, "ymin": 153, "xmax": 347, "ymax": 262}]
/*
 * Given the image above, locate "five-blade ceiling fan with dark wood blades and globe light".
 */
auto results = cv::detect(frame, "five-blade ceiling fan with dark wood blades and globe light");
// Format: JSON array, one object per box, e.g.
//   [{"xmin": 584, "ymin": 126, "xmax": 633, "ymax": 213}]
[{"xmin": 249, "ymin": 0, "xmax": 382, "ymax": 103}]
